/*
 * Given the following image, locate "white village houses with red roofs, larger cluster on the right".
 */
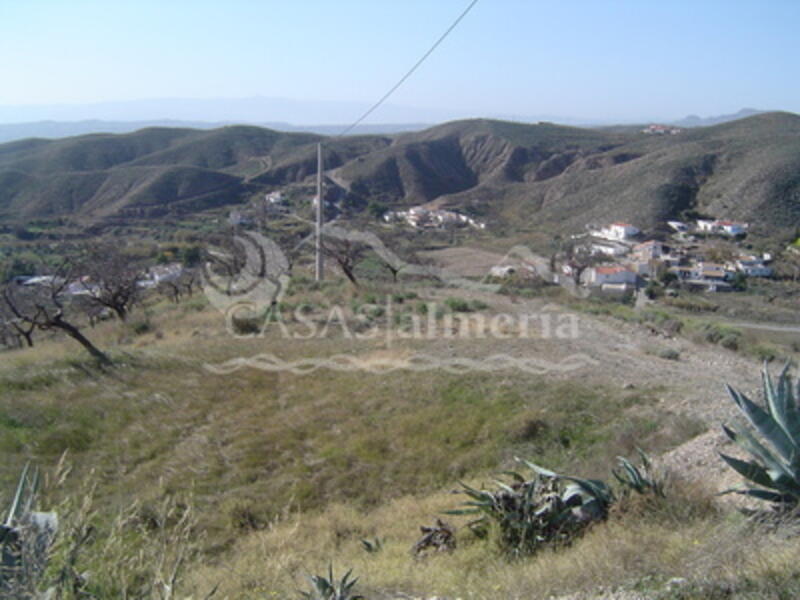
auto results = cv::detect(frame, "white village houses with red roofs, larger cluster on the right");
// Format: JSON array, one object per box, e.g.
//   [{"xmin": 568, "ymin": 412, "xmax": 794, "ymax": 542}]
[{"xmin": 562, "ymin": 219, "xmax": 772, "ymax": 291}]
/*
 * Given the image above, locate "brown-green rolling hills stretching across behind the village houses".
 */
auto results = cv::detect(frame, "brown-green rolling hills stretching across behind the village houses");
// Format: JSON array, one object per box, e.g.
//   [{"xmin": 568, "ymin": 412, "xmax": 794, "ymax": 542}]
[{"xmin": 0, "ymin": 112, "xmax": 800, "ymax": 237}]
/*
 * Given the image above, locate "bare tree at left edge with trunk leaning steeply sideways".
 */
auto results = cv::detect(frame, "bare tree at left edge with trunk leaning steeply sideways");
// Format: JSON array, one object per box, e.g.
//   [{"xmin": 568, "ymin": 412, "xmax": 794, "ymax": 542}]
[{"xmin": 2, "ymin": 263, "xmax": 111, "ymax": 365}]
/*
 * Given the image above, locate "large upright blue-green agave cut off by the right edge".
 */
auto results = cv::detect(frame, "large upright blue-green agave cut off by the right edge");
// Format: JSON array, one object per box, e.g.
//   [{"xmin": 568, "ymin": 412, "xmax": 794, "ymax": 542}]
[{"xmin": 720, "ymin": 364, "xmax": 800, "ymax": 508}]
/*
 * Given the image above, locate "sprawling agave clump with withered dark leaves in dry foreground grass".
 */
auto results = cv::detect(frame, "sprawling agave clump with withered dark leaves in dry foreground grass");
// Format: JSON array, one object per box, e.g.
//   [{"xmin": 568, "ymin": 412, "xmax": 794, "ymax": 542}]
[{"xmin": 447, "ymin": 458, "xmax": 614, "ymax": 556}]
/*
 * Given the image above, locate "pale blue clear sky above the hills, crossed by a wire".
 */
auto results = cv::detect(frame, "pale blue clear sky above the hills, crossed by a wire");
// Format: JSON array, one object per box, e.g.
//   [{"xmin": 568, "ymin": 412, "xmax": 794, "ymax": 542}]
[{"xmin": 0, "ymin": 0, "xmax": 800, "ymax": 123}]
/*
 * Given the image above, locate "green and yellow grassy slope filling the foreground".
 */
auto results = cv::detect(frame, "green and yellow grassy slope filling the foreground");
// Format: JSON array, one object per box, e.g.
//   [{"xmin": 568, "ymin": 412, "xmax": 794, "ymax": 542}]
[{"xmin": 0, "ymin": 282, "xmax": 800, "ymax": 599}]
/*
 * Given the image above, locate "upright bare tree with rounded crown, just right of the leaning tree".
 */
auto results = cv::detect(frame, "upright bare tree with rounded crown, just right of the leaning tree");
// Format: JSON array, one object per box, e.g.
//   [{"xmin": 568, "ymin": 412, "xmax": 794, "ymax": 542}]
[{"xmin": 79, "ymin": 244, "xmax": 145, "ymax": 321}]
